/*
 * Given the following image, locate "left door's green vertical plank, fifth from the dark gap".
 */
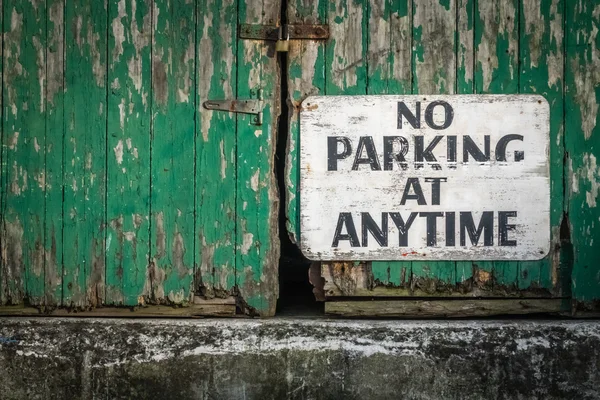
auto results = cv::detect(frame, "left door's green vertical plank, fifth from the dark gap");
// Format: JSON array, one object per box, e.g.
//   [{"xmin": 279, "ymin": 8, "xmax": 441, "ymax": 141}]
[{"xmin": 62, "ymin": 0, "xmax": 108, "ymax": 308}]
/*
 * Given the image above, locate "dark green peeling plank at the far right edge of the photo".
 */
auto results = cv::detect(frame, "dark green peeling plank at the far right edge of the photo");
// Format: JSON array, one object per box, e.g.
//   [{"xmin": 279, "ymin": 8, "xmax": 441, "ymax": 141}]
[{"xmin": 565, "ymin": 0, "xmax": 600, "ymax": 307}]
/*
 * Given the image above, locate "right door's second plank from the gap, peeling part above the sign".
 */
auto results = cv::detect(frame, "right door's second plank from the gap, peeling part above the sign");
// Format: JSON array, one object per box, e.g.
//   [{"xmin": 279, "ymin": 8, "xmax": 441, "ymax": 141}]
[{"xmin": 325, "ymin": 0, "xmax": 369, "ymax": 95}]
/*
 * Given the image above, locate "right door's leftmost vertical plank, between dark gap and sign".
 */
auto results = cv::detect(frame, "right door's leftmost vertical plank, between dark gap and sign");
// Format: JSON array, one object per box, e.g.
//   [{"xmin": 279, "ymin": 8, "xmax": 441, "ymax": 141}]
[{"xmin": 282, "ymin": 0, "xmax": 327, "ymax": 243}]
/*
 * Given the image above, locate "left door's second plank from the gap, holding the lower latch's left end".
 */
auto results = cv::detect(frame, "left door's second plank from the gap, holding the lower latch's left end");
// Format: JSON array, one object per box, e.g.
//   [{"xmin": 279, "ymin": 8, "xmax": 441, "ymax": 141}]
[{"xmin": 194, "ymin": 0, "xmax": 237, "ymax": 298}]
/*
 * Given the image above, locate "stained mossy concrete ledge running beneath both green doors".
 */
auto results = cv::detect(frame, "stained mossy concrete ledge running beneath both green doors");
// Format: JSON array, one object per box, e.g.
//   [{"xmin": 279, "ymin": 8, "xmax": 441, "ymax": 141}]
[{"xmin": 0, "ymin": 318, "xmax": 600, "ymax": 399}]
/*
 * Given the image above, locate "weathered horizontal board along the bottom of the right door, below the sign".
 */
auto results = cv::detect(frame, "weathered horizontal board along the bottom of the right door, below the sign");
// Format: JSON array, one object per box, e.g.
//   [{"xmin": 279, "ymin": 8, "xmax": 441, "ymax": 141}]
[{"xmin": 325, "ymin": 299, "xmax": 566, "ymax": 318}]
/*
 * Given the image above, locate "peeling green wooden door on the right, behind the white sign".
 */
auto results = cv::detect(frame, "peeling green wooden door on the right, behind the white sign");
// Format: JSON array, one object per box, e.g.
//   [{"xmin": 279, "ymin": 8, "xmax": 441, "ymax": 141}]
[{"xmin": 286, "ymin": 0, "xmax": 600, "ymax": 315}]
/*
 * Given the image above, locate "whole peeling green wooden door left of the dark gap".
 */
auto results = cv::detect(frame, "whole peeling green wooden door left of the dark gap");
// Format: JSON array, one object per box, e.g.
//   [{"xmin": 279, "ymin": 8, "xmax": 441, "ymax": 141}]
[{"xmin": 0, "ymin": 0, "xmax": 279, "ymax": 315}]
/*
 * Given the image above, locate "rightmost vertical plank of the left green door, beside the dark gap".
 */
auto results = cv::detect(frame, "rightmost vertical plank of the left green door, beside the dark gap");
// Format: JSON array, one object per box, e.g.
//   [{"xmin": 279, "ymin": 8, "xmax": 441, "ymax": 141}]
[{"xmin": 236, "ymin": 0, "xmax": 280, "ymax": 316}]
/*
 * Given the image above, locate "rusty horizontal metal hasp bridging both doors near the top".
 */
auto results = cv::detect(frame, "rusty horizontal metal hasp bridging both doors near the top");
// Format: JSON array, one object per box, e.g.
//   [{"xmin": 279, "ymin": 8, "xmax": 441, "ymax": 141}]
[{"xmin": 239, "ymin": 24, "xmax": 329, "ymax": 41}]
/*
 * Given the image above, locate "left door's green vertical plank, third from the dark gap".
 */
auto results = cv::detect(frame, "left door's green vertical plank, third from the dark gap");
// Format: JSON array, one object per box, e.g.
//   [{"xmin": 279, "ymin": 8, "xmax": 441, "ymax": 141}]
[{"xmin": 149, "ymin": 0, "xmax": 196, "ymax": 304}]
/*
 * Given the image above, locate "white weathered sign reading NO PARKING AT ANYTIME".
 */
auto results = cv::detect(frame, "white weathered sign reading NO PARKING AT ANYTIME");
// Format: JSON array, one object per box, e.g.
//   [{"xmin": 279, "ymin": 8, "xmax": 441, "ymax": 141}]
[{"xmin": 300, "ymin": 95, "xmax": 550, "ymax": 260}]
